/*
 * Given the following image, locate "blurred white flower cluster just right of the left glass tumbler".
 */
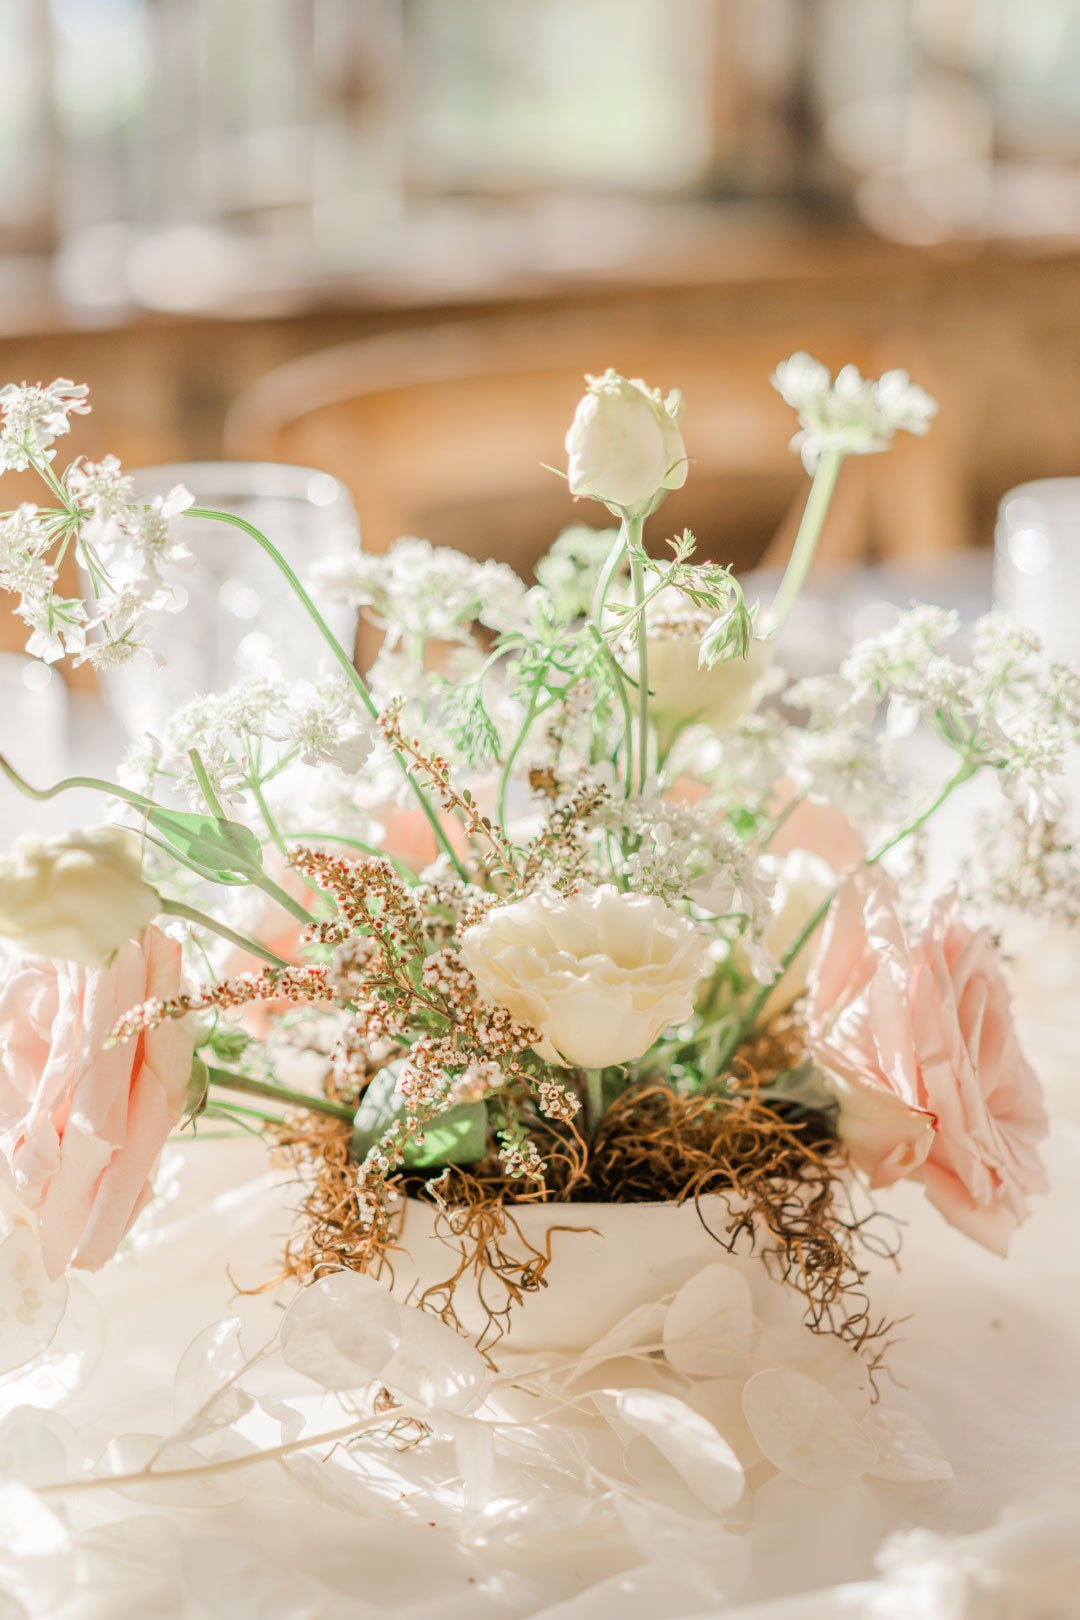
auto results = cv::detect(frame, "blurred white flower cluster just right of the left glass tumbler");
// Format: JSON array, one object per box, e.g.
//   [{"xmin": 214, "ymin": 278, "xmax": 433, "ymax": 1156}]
[{"xmin": 313, "ymin": 536, "xmax": 528, "ymax": 646}]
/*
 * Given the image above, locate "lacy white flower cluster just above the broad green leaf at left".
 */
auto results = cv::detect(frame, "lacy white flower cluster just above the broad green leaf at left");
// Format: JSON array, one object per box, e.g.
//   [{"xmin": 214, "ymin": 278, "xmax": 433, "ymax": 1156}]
[{"xmin": 121, "ymin": 674, "xmax": 374, "ymax": 807}]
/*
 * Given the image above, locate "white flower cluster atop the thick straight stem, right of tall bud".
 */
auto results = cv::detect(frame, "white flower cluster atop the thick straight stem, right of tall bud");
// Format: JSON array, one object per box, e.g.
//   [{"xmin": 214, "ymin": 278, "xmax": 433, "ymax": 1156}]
[{"xmin": 772, "ymin": 352, "xmax": 938, "ymax": 473}]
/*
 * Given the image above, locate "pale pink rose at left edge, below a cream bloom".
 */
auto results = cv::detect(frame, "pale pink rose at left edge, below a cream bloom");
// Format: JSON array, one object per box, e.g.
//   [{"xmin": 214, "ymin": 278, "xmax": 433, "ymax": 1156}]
[{"xmin": 0, "ymin": 925, "xmax": 194, "ymax": 1277}]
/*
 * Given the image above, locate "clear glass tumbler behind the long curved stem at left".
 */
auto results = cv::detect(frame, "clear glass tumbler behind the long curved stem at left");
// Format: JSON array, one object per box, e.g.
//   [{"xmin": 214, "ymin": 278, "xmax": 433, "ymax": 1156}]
[{"xmin": 93, "ymin": 462, "xmax": 359, "ymax": 737}]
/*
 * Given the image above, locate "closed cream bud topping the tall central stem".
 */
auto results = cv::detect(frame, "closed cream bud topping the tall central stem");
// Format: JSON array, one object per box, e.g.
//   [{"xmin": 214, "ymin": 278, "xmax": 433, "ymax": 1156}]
[{"xmin": 567, "ymin": 371, "xmax": 687, "ymax": 512}]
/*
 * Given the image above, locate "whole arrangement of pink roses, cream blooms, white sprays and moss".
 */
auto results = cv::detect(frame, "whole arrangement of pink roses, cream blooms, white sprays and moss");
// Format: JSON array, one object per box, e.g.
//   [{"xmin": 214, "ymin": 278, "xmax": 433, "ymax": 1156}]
[{"xmin": 0, "ymin": 355, "xmax": 1080, "ymax": 1345}]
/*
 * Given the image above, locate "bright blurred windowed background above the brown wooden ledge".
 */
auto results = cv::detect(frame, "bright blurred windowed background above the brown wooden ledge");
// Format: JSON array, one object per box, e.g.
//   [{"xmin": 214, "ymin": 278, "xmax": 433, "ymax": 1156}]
[{"xmin": 0, "ymin": 0, "xmax": 1080, "ymax": 306}]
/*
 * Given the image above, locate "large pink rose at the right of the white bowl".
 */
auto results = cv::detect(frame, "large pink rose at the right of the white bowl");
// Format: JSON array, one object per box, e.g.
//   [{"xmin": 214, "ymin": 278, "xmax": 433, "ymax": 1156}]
[{"xmin": 808, "ymin": 868, "xmax": 1046, "ymax": 1254}]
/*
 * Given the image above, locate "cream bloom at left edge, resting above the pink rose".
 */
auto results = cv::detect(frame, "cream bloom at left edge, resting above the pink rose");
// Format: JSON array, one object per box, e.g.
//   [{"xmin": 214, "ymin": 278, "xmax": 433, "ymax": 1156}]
[{"xmin": 0, "ymin": 826, "xmax": 162, "ymax": 967}]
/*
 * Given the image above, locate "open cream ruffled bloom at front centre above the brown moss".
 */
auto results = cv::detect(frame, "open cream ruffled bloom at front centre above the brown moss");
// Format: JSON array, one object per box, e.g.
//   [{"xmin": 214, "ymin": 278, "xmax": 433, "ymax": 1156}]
[{"xmin": 461, "ymin": 885, "xmax": 704, "ymax": 1069}]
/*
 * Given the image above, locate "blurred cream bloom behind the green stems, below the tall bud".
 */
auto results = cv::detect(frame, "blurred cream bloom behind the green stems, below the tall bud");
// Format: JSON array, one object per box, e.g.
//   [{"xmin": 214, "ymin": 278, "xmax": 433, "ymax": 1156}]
[{"xmin": 646, "ymin": 632, "xmax": 772, "ymax": 744}]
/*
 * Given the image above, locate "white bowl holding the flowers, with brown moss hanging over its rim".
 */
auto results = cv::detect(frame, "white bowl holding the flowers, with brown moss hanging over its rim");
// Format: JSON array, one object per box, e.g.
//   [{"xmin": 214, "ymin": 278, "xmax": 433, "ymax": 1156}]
[{"xmin": 392, "ymin": 1192, "xmax": 751, "ymax": 1353}]
